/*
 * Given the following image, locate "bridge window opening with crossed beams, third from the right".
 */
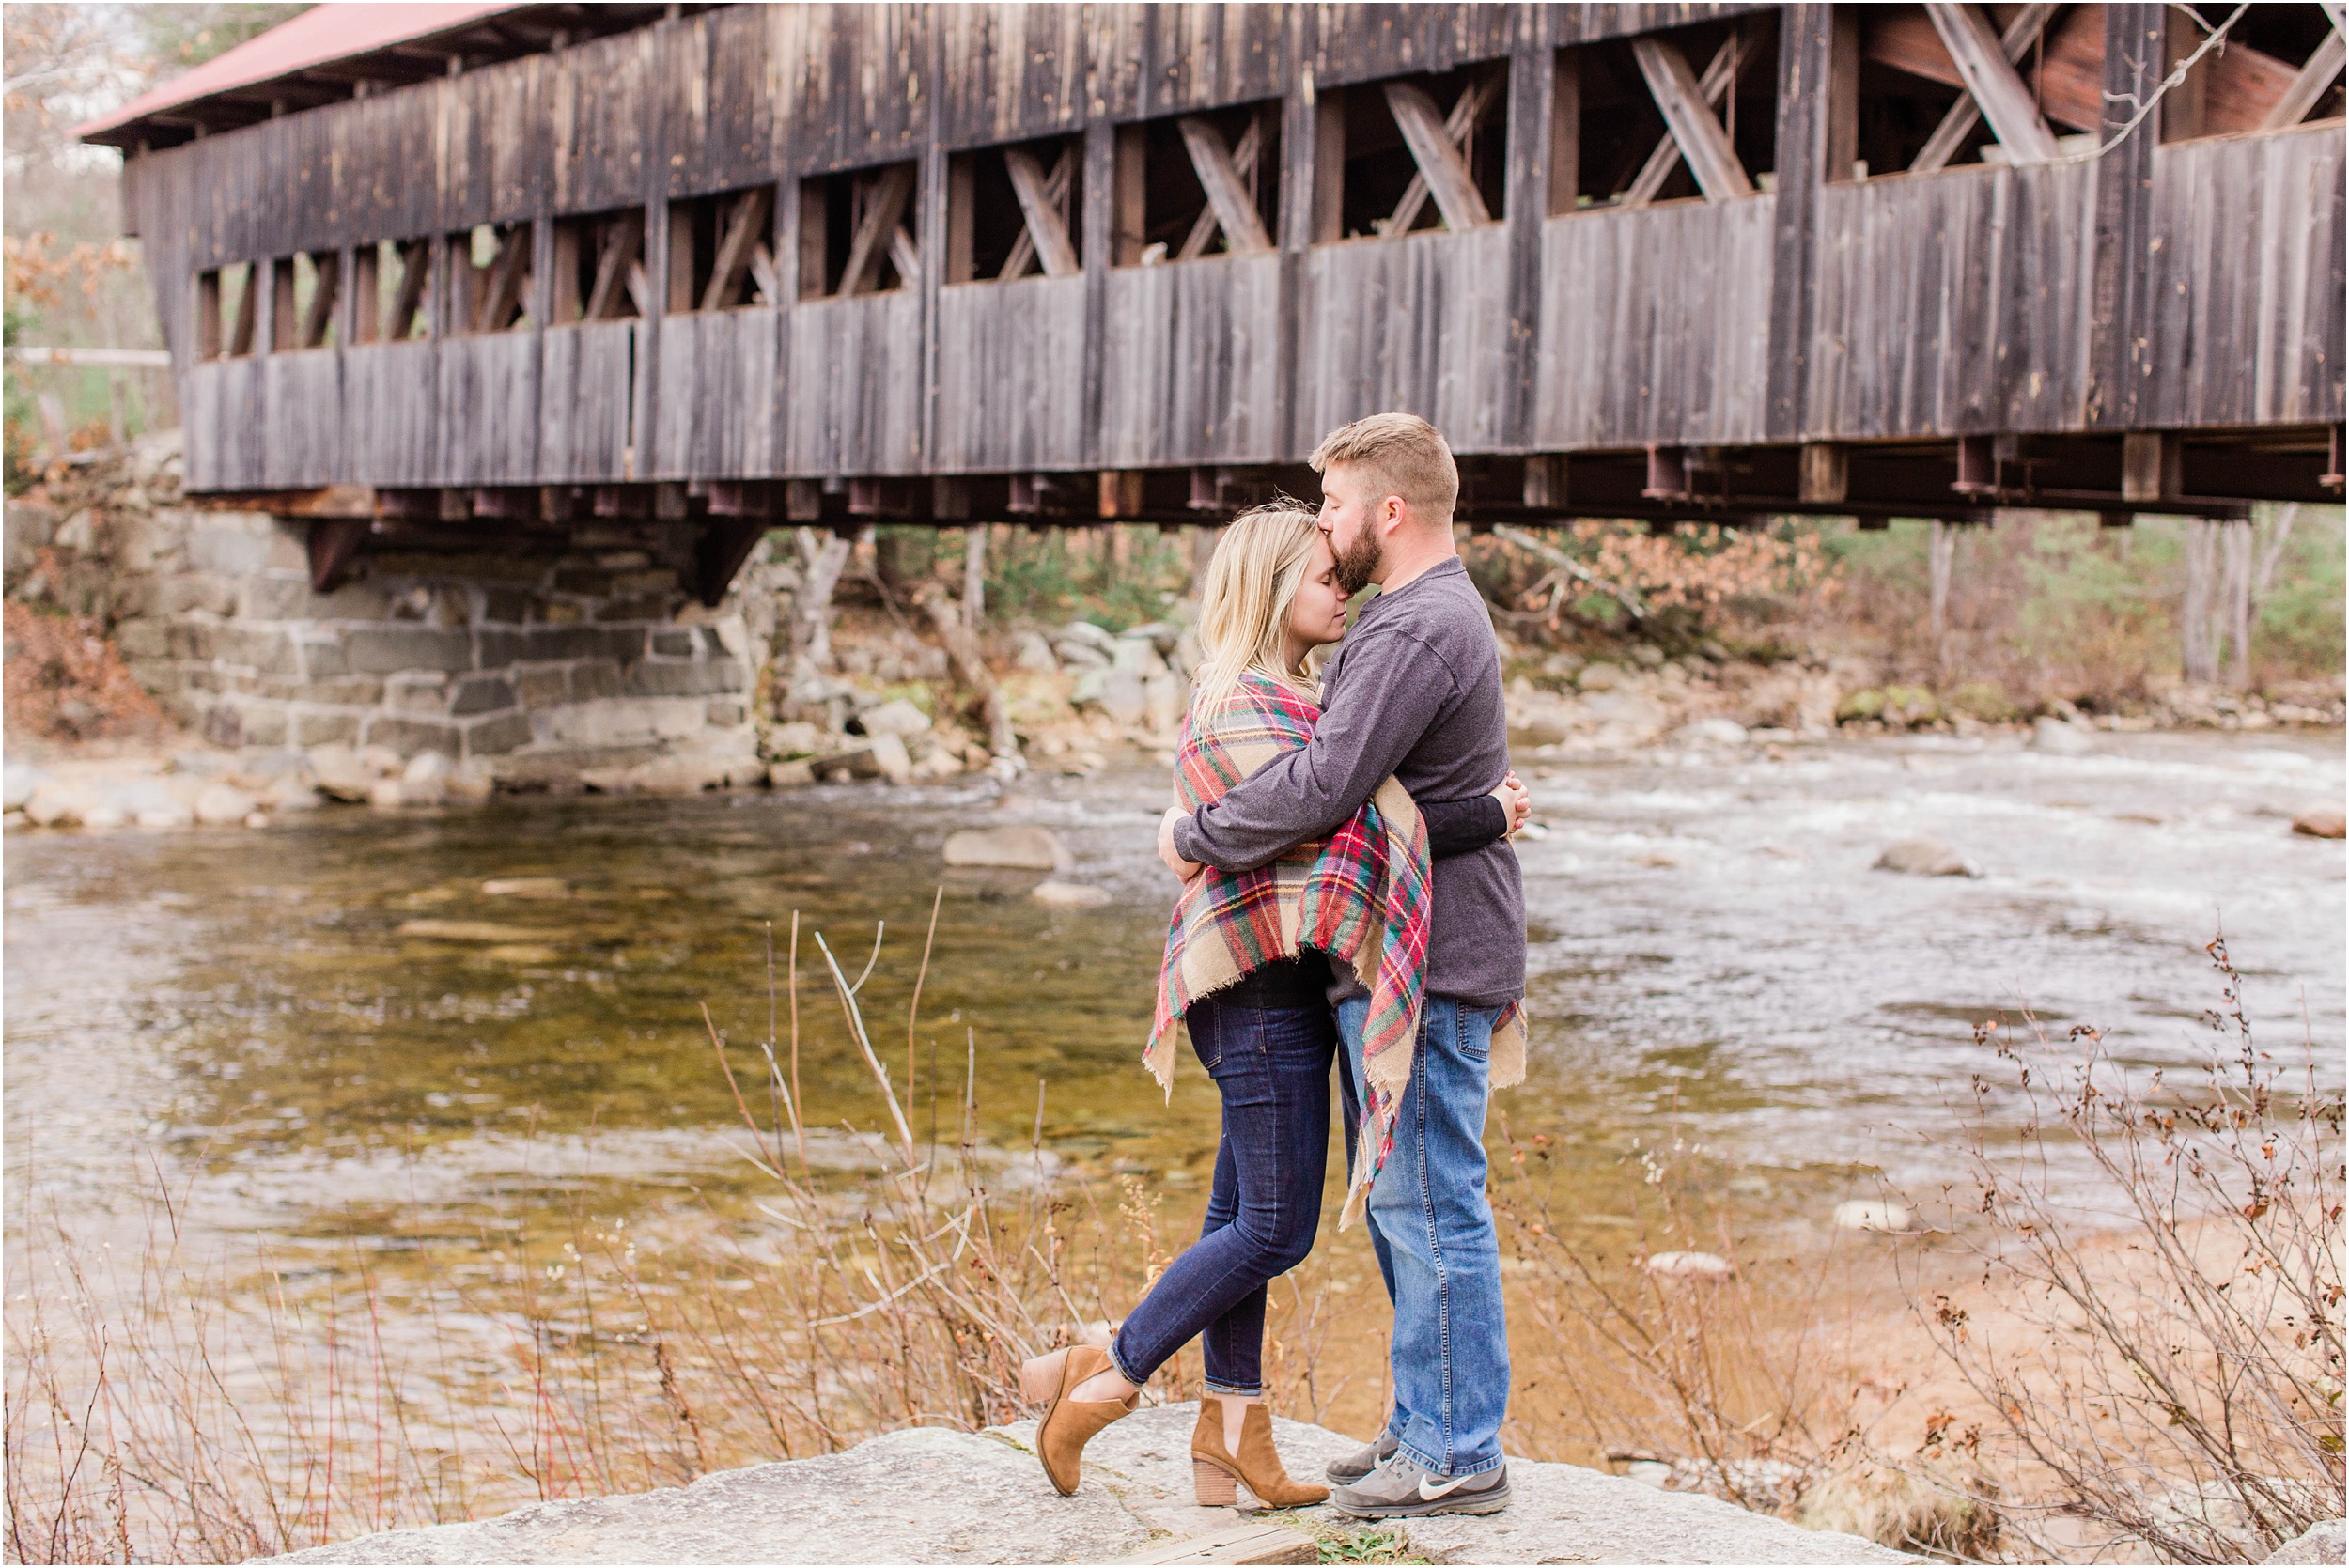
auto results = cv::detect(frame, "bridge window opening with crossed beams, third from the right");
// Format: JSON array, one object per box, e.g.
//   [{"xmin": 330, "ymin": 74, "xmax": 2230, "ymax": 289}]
[{"xmin": 1553, "ymin": 16, "xmax": 1779, "ymax": 209}]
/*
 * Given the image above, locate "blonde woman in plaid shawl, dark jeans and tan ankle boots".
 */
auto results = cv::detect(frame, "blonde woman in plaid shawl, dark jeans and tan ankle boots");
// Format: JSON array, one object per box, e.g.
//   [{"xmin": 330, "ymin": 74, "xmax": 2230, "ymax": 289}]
[{"xmin": 1019, "ymin": 503, "xmax": 1525, "ymax": 1507}]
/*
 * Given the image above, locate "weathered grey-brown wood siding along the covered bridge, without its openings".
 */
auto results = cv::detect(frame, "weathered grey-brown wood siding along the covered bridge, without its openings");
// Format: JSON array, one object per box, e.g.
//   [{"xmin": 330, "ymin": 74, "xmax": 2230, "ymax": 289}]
[{"xmin": 125, "ymin": 5, "xmax": 2349, "ymax": 490}]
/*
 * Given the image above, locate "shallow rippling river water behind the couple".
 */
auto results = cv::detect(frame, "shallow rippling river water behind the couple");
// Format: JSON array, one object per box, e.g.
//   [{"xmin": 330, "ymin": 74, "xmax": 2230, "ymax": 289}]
[{"xmin": 5, "ymin": 735, "xmax": 2344, "ymax": 1277}]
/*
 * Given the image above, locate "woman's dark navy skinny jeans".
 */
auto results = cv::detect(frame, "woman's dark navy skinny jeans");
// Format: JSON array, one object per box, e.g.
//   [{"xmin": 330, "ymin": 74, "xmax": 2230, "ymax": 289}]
[{"xmin": 1109, "ymin": 998, "xmax": 1337, "ymax": 1397}]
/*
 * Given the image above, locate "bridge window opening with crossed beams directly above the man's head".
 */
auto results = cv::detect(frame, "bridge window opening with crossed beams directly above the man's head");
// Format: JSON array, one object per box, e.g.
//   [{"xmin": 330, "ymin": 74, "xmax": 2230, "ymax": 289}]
[{"xmin": 1315, "ymin": 61, "xmax": 1508, "ymax": 240}]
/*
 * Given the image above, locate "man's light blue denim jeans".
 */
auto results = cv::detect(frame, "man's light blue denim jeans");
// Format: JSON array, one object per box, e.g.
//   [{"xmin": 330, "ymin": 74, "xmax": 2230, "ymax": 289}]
[{"xmin": 1337, "ymin": 995, "xmax": 1508, "ymax": 1477}]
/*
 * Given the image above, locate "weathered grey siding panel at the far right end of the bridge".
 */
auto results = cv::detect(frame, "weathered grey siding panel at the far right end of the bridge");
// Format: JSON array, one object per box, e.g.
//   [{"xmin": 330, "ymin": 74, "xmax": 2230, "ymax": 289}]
[{"xmin": 2147, "ymin": 124, "xmax": 2349, "ymax": 425}]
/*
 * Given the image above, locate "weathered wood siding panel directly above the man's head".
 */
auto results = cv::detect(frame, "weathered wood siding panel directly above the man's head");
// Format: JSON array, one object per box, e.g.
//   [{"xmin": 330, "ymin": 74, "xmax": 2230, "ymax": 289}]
[{"xmin": 1292, "ymin": 223, "xmax": 1508, "ymax": 451}]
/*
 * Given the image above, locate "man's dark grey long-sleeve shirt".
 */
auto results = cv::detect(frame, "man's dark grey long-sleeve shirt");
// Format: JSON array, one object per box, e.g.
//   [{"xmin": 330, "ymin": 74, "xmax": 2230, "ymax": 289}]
[{"xmin": 1174, "ymin": 559, "xmax": 1525, "ymax": 1007}]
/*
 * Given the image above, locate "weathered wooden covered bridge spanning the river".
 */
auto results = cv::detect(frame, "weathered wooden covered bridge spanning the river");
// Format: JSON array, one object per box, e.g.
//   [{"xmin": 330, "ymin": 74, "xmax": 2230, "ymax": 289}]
[{"xmin": 85, "ymin": 5, "xmax": 2344, "ymax": 594}]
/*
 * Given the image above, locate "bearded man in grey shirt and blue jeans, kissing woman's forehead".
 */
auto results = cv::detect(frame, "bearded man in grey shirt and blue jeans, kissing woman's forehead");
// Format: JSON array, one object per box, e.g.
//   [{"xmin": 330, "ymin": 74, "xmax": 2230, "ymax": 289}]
[{"xmin": 1159, "ymin": 413, "xmax": 1525, "ymax": 1519}]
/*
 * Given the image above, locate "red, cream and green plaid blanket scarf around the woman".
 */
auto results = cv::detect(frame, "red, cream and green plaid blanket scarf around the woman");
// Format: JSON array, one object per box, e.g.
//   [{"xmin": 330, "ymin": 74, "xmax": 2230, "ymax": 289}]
[{"xmin": 1142, "ymin": 674, "xmax": 1525, "ymax": 1230}]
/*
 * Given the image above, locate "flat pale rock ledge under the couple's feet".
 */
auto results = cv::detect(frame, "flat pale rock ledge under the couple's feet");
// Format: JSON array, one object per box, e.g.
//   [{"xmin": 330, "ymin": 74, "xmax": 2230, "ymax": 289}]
[{"xmin": 266, "ymin": 1404, "xmax": 1920, "ymax": 1563}]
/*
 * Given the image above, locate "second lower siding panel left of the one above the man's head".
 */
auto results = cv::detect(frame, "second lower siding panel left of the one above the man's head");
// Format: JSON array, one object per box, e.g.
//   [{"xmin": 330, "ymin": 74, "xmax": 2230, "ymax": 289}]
[{"xmin": 933, "ymin": 277, "xmax": 1085, "ymax": 474}]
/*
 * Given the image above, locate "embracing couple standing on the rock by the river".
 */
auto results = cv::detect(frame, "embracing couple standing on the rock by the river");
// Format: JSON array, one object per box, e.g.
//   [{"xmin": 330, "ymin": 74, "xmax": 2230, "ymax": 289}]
[{"xmin": 1022, "ymin": 413, "xmax": 1527, "ymax": 1519}]
